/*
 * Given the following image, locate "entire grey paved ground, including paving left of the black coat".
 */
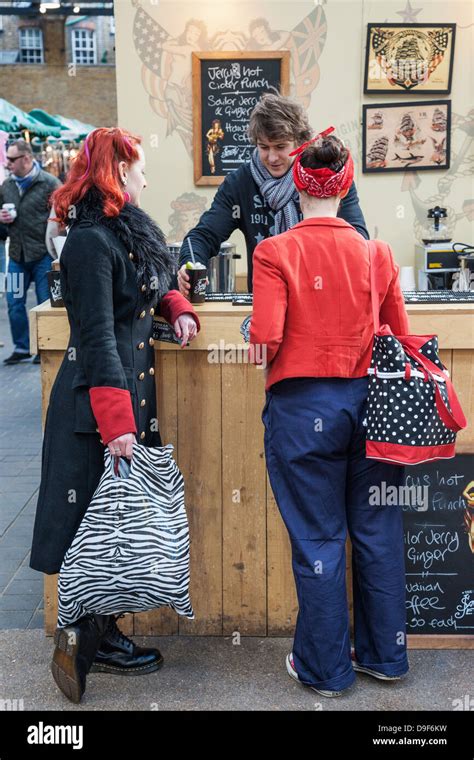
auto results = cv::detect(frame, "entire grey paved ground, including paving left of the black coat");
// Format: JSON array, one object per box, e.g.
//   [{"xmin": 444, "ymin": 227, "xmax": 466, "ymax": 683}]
[{"xmin": 0, "ymin": 291, "xmax": 474, "ymax": 711}]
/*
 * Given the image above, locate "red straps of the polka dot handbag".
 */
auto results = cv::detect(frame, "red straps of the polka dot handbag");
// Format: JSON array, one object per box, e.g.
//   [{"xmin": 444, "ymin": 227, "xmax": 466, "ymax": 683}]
[{"xmin": 368, "ymin": 240, "xmax": 467, "ymax": 432}]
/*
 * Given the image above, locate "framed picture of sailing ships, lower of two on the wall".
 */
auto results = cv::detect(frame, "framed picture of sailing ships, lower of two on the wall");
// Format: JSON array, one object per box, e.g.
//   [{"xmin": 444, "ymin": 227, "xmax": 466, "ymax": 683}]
[{"xmin": 362, "ymin": 100, "xmax": 451, "ymax": 172}]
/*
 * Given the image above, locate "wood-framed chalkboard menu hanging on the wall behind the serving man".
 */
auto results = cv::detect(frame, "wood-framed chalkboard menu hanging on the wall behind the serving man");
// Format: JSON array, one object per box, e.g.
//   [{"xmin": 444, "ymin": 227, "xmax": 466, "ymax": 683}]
[{"xmin": 192, "ymin": 50, "xmax": 290, "ymax": 185}]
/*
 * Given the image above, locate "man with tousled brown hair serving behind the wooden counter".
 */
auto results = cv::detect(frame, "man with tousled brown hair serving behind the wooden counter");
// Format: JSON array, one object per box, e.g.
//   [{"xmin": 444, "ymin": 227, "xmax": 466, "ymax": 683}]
[{"xmin": 178, "ymin": 93, "xmax": 369, "ymax": 295}]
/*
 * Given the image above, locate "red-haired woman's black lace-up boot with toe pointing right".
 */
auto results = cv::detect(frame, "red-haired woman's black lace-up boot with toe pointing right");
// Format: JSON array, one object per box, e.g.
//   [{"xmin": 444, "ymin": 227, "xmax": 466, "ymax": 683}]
[{"xmin": 91, "ymin": 615, "xmax": 163, "ymax": 676}]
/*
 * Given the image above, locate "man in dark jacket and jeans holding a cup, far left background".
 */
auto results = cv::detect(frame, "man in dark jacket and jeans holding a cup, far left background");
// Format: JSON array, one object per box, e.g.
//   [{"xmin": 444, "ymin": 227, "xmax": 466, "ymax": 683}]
[{"xmin": 0, "ymin": 140, "xmax": 61, "ymax": 364}]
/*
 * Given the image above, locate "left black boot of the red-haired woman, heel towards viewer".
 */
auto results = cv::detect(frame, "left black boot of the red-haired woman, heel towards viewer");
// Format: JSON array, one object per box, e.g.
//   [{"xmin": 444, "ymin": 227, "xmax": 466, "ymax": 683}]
[{"xmin": 51, "ymin": 614, "xmax": 112, "ymax": 704}]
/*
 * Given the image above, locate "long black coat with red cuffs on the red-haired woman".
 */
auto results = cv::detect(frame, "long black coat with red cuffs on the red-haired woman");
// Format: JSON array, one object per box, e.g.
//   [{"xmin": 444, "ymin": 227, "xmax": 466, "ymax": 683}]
[{"xmin": 30, "ymin": 193, "xmax": 189, "ymax": 574}]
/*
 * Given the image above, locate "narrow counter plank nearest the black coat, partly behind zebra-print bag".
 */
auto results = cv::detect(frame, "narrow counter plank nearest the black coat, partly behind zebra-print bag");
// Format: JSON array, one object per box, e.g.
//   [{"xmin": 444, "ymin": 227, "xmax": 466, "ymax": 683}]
[{"xmin": 133, "ymin": 351, "xmax": 178, "ymax": 636}]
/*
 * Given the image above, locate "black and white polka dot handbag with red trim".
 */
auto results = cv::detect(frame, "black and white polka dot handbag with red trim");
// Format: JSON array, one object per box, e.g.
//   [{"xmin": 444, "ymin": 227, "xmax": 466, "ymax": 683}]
[{"xmin": 366, "ymin": 243, "xmax": 467, "ymax": 465}]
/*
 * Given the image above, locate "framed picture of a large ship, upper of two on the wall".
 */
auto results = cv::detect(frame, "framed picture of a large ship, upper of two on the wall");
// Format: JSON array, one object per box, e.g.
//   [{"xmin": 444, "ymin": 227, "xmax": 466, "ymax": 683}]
[{"xmin": 364, "ymin": 24, "xmax": 456, "ymax": 95}]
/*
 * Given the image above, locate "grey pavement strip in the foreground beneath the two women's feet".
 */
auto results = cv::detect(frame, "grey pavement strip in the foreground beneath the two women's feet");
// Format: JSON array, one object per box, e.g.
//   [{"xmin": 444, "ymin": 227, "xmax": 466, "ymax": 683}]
[{"xmin": 0, "ymin": 630, "xmax": 474, "ymax": 711}]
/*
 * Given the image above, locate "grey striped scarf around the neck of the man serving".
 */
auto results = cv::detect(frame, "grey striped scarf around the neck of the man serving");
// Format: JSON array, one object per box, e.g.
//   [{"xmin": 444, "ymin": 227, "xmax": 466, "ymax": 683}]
[{"xmin": 250, "ymin": 148, "xmax": 301, "ymax": 235}]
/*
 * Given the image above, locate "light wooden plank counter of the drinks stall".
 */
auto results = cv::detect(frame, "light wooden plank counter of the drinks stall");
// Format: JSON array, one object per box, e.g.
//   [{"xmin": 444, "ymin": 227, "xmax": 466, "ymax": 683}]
[{"xmin": 30, "ymin": 302, "xmax": 474, "ymax": 647}]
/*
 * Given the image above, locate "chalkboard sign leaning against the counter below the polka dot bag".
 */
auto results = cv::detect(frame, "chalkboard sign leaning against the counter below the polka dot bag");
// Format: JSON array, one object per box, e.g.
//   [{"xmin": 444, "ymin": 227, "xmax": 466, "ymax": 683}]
[{"xmin": 403, "ymin": 454, "xmax": 474, "ymax": 646}]
